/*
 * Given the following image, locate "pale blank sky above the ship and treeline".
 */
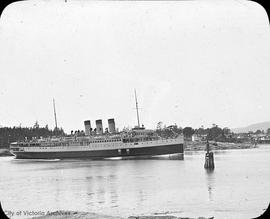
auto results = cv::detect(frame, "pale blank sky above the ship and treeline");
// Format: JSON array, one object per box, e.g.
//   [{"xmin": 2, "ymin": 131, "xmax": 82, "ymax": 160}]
[{"xmin": 0, "ymin": 0, "xmax": 270, "ymax": 133}]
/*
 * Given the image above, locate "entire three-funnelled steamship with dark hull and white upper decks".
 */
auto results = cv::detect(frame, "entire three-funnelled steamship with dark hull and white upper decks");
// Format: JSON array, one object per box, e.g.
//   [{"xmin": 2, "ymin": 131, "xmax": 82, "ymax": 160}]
[{"xmin": 10, "ymin": 92, "xmax": 184, "ymax": 159}]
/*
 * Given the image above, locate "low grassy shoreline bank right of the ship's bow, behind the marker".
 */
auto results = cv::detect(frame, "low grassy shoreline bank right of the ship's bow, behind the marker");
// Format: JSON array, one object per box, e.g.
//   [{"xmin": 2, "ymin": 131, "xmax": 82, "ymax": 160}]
[{"xmin": 185, "ymin": 141, "xmax": 257, "ymax": 151}]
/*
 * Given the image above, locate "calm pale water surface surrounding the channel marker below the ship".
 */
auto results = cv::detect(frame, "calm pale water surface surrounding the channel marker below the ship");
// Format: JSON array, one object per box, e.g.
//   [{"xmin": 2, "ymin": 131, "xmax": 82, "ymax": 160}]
[{"xmin": 0, "ymin": 145, "xmax": 270, "ymax": 219}]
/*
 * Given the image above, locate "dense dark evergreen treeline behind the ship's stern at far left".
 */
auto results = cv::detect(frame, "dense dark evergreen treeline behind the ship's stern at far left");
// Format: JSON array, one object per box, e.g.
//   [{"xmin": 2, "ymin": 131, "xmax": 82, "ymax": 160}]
[{"xmin": 0, "ymin": 122, "xmax": 65, "ymax": 148}]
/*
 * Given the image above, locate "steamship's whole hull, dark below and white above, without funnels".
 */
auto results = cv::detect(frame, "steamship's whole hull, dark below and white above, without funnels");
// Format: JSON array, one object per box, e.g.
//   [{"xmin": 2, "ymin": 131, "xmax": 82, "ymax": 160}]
[{"xmin": 10, "ymin": 136, "xmax": 184, "ymax": 159}]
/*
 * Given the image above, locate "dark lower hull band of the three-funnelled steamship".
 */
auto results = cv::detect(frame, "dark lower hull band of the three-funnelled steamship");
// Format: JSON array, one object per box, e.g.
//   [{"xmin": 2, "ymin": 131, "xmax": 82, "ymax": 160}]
[{"xmin": 13, "ymin": 144, "xmax": 184, "ymax": 159}]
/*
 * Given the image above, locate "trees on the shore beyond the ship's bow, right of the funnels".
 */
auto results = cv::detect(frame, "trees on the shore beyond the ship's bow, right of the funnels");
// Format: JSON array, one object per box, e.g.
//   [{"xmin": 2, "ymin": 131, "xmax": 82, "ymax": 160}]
[{"xmin": 156, "ymin": 122, "xmax": 240, "ymax": 142}]
